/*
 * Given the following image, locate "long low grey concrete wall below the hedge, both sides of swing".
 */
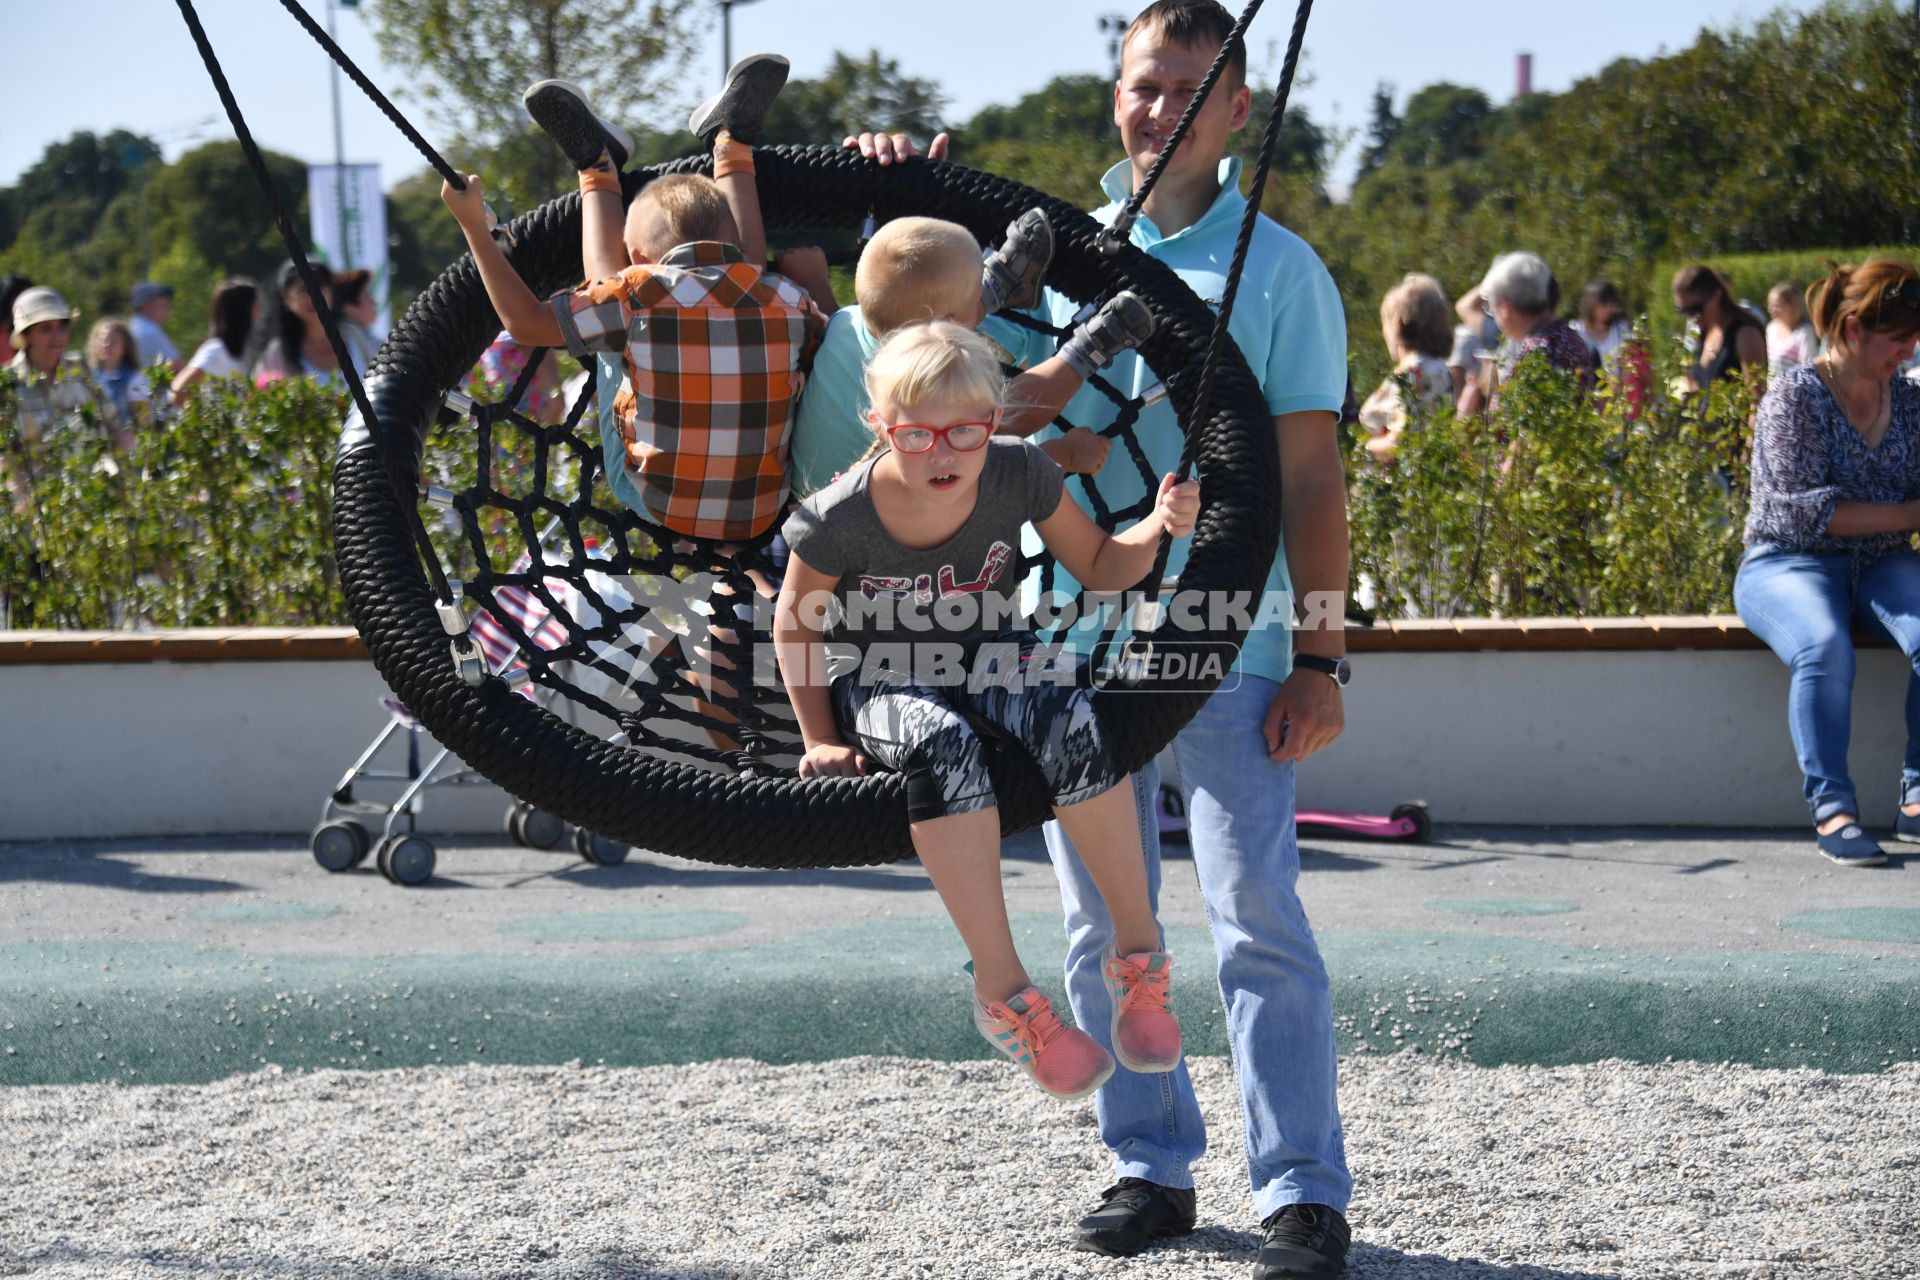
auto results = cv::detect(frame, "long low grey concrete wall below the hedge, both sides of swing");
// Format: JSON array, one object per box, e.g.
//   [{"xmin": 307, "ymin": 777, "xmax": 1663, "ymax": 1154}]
[{"xmin": 0, "ymin": 624, "xmax": 1905, "ymax": 839}]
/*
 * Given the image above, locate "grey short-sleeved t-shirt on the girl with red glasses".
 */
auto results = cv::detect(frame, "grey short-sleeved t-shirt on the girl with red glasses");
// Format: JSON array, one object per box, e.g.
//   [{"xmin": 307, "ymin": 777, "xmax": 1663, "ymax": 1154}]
[{"xmin": 781, "ymin": 436, "xmax": 1066, "ymax": 676}]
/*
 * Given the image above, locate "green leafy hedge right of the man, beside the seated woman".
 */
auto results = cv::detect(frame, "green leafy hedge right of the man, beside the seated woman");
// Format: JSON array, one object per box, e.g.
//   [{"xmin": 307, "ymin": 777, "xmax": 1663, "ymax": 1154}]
[{"xmin": 1348, "ymin": 343, "xmax": 1755, "ymax": 618}]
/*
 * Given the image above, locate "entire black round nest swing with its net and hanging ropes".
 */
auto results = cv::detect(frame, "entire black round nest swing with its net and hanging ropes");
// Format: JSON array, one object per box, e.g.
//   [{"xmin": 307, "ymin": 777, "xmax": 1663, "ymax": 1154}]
[{"xmin": 175, "ymin": 0, "xmax": 1311, "ymax": 883}]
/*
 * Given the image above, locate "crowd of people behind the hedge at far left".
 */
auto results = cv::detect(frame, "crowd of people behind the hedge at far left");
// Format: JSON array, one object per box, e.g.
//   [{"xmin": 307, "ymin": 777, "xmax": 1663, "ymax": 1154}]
[{"xmin": 0, "ymin": 261, "xmax": 389, "ymax": 445}]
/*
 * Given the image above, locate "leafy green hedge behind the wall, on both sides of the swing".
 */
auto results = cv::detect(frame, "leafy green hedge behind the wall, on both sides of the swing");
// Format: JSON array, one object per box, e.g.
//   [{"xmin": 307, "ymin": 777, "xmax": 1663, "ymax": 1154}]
[{"xmin": 0, "ymin": 345, "xmax": 1753, "ymax": 629}]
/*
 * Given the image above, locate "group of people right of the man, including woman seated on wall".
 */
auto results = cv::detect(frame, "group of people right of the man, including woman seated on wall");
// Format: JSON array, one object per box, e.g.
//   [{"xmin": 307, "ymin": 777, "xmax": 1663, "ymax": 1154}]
[{"xmin": 1357, "ymin": 253, "xmax": 1920, "ymax": 865}]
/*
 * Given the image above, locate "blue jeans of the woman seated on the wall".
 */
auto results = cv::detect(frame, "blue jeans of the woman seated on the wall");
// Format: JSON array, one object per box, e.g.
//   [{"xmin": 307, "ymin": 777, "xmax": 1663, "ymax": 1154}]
[{"xmin": 1734, "ymin": 543, "xmax": 1920, "ymax": 823}]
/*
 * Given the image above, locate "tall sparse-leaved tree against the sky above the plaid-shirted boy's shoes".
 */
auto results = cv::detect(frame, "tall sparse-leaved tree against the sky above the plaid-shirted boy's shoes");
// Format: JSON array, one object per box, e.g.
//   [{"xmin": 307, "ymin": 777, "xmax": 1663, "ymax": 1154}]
[{"xmin": 372, "ymin": 0, "xmax": 710, "ymax": 201}]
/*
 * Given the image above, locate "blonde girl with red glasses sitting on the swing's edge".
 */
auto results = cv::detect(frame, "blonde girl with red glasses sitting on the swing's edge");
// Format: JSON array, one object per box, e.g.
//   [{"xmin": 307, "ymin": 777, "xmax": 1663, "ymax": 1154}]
[{"xmin": 774, "ymin": 320, "xmax": 1200, "ymax": 1098}]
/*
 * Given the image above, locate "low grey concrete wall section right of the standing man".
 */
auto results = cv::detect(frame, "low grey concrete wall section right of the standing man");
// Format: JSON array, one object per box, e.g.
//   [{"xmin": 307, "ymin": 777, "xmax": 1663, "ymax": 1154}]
[{"xmin": 1300, "ymin": 649, "xmax": 1907, "ymax": 827}]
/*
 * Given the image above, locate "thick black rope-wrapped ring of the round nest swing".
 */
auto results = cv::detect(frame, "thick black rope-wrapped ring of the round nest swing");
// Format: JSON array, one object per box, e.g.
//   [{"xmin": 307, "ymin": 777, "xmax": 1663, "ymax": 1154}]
[{"xmin": 334, "ymin": 148, "xmax": 1279, "ymax": 867}]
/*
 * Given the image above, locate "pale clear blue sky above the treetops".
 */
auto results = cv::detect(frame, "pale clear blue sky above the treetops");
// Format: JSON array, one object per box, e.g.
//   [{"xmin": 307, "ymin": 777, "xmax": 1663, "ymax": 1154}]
[{"xmin": 0, "ymin": 0, "xmax": 1814, "ymax": 184}]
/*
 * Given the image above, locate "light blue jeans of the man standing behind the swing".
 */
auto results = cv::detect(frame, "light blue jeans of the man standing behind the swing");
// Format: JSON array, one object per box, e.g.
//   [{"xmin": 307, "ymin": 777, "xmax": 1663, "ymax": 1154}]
[{"xmin": 1046, "ymin": 676, "xmax": 1354, "ymax": 1217}]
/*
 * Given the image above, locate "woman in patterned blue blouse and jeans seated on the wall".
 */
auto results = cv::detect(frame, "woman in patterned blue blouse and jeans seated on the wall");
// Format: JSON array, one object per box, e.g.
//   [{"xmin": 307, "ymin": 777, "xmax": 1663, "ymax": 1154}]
[{"xmin": 1734, "ymin": 259, "xmax": 1920, "ymax": 867}]
